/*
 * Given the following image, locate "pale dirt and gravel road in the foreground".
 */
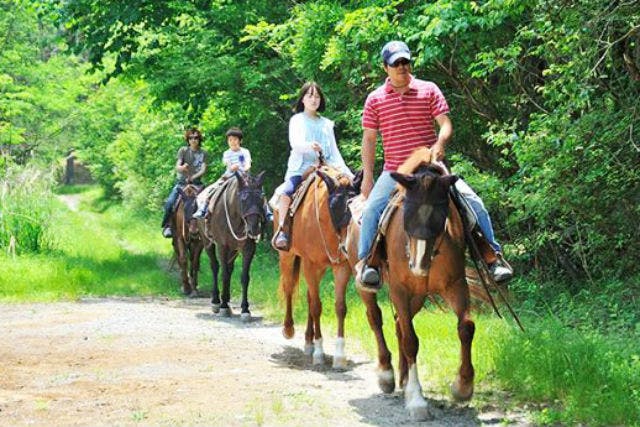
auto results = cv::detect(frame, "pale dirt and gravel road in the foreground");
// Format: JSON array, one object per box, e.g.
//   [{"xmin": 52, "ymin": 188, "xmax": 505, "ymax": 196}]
[{"xmin": 0, "ymin": 299, "xmax": 526, "ymax": 427}]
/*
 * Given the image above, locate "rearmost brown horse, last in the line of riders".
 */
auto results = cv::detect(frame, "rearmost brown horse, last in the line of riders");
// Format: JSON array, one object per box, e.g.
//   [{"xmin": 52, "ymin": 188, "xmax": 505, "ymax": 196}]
[{"xmin": 171, "ymin": 184, "xmax": 204, "ymax": 297}]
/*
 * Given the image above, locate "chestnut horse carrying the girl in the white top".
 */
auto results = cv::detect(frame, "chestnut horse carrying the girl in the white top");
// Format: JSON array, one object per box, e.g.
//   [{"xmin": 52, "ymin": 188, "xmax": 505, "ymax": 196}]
[{"xmin": 274, "ymin": 166, "xmax": 354, "ymax": 368}]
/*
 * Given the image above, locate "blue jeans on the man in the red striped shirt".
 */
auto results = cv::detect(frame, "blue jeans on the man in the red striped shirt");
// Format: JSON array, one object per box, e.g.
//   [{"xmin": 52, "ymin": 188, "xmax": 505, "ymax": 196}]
[{"xmin": 358, "ymin": 172, "xmax": 502, "ymax": 259}]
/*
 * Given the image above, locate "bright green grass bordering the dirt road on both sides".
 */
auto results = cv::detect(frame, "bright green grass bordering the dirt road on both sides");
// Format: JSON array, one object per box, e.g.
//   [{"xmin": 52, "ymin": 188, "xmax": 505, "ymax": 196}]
[{"xmin": 0, "ymin": 186, "xmax": 640, "ymax": 426}]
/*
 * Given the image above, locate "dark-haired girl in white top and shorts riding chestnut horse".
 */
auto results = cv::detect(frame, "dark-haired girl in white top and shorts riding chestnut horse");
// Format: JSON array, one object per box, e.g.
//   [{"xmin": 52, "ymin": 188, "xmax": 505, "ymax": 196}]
[{"xmin": 274, "ymin": 82, "xmax": 353, "ymax": 249}]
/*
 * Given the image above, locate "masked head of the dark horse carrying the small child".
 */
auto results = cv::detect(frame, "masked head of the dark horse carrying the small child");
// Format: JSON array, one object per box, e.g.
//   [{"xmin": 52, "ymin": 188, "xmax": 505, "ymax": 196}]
[{"xmin": 235, "ymin": 171, "xmax": 265, "ymax": 239}]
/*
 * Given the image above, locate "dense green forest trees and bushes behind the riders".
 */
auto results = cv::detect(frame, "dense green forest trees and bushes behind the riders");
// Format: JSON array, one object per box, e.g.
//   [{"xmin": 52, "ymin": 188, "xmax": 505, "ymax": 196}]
[{"xmin": 0, "ymin": 0, "xmax": 640, "ymax": 426}]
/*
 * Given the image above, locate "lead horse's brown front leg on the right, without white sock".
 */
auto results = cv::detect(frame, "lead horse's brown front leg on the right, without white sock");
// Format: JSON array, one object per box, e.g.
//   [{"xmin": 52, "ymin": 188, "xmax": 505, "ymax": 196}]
[{"xmin": 442, "ymin": 277, "xmax": 476, "ymax": 401}]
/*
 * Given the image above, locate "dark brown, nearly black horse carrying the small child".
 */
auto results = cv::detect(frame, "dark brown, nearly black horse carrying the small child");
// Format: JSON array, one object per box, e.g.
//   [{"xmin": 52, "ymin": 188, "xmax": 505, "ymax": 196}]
[{"xmin": 204, "ymin": 172, "xmax": 265, "ymax": 321}]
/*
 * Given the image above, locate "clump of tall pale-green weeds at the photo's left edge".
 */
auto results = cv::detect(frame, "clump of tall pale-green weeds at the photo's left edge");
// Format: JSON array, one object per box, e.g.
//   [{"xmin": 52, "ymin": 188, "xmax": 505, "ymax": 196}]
[{"xmin": 0, "ymin": 166, "xmax": 53, "ymax": 255}]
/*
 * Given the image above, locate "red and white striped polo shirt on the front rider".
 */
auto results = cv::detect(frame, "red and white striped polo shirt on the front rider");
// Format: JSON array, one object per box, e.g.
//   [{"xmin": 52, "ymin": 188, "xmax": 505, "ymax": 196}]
[{"xmin": 362, "ymin": 76, "xmax": 449, "ymax": 171}]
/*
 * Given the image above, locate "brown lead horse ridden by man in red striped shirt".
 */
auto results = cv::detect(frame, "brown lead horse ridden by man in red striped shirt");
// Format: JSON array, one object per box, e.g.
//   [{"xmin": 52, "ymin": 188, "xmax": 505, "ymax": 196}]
[{"xmin": 348, "ymin": 165, "xmax": 475, "ymax": 420}]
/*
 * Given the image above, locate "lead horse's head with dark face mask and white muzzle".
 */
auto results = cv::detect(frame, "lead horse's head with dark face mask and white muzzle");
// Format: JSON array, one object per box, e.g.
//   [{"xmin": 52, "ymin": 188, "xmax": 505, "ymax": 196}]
[{"xmin": 391, "ymin": 165, "xmax": 458, "ymax": 276}]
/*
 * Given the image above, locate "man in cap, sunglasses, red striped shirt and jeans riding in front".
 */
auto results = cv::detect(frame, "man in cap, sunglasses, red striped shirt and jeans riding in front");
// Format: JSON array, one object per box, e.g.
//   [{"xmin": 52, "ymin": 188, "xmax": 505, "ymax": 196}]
[{"xmin": 356, "ymin": 41, "xmax": 513, "ymax": 292}]
